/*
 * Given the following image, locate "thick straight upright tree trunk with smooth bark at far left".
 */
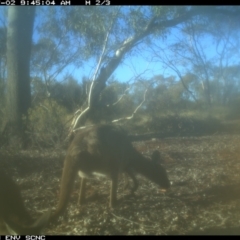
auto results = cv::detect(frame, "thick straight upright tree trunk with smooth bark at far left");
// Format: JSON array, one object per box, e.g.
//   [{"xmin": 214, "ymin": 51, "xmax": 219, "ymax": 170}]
[{"xmin": 5, "ymin": 7, "xmax": 35, "ymax": 146}]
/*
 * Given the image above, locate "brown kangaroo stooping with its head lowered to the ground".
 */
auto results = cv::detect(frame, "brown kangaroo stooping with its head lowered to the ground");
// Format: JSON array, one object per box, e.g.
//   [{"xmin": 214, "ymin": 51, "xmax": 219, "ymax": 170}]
[{"xmin": 51, "ymin": 125, "xmax": 170, "ymax": 220}]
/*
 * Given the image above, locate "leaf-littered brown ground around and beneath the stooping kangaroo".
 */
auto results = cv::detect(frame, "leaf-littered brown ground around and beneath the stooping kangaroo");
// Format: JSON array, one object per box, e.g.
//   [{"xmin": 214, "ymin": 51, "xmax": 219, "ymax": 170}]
[{"xmin": 0, "ymin": 134, "xmax": 240, "ymax": 235}]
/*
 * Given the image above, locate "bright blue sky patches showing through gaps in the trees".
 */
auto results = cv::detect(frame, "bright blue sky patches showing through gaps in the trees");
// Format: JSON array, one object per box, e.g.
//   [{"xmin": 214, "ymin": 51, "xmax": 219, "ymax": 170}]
[{"xmin": 0, "ymin": 7, "xmax": 238, "ymax": 86}]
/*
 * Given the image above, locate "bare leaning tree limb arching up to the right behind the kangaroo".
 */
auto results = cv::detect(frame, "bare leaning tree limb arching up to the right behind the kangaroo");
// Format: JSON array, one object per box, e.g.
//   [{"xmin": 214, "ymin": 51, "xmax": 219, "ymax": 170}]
[{"xmin": 70, "ymin": 6, "xmax": 240, "ymax": 131}]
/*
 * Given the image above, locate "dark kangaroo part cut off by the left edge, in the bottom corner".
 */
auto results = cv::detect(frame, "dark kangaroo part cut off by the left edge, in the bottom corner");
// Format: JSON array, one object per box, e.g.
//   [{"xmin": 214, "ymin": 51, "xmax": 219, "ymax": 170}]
[{"xmin": 0, "ymin": 169, "xmax": 50, "ymax": 235}]
